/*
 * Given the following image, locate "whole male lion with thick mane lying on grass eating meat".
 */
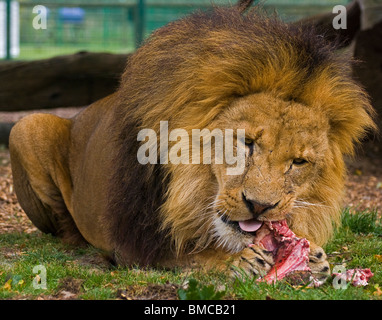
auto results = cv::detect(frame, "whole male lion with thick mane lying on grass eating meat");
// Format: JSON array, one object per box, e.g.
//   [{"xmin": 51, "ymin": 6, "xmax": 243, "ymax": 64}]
[{"xmin": 10, "ymin": 7, "xmax": 374, "ymax": 280}]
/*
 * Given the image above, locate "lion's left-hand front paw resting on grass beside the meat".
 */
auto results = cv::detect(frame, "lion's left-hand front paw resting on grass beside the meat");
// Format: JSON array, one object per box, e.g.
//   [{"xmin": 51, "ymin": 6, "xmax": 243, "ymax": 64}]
[{"xmin": 231, "ymin": 245, "xmax": 274, "ymax": 277}]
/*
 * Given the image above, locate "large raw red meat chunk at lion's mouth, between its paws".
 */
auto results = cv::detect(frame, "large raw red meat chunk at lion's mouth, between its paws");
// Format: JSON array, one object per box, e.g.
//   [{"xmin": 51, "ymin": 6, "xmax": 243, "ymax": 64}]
[{"xmin": 253, "ymin": 220, "xmax": 310, "ymax": 283}]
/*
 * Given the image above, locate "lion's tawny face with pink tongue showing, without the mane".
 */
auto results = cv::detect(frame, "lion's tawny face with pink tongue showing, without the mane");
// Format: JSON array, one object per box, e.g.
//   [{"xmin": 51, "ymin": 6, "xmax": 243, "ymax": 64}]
[{"xmin": 211, "ymin": 93, "xmax": 332, "ymax": 250}]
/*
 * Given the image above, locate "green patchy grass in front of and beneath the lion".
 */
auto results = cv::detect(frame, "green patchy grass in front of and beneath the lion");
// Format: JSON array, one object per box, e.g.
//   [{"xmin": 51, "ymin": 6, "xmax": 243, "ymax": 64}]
[{"xmin": 0, "ymin": 210, "xmax": 382, "ymax": 300}]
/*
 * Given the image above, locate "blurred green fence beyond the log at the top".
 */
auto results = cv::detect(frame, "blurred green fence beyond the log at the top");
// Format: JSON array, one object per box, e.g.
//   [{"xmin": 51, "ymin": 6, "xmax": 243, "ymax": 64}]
[{"xmin": 0, "ymin": 0, "xmax": 349, "ymax": 59}]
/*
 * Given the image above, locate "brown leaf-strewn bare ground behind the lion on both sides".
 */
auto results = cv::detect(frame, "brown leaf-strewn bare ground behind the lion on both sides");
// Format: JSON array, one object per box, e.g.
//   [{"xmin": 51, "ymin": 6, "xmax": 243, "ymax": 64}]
[{"xmin": 0, "ymin": 108, "xmax": 382, "ymax": 234}]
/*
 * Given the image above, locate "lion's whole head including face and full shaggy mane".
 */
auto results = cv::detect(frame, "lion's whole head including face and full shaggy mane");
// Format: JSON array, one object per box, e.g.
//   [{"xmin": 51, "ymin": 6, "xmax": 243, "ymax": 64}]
[{"xmin": 110, "ymin": 8, "xmax": 374, "ymax": 262}]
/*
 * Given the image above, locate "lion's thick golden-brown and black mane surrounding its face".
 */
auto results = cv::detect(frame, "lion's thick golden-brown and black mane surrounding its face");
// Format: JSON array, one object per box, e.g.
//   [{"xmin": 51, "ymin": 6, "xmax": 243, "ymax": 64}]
[{"xmin": 105, "ymin": 7, "xmax": 373, "ymax": 264}]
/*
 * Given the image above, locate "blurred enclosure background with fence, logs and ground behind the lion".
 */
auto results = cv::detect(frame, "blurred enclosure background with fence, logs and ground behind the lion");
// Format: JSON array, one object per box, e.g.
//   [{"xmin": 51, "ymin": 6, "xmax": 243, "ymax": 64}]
[{"xmin": 0, "ymin": 0, "xmax": 382, "ymax": 212}]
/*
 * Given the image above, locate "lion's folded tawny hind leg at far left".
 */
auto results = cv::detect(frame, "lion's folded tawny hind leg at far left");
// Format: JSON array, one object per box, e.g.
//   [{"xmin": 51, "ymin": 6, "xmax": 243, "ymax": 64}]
[{"xmin": 9, "ymin": 114, "xmax": 86, "ymax": 242}]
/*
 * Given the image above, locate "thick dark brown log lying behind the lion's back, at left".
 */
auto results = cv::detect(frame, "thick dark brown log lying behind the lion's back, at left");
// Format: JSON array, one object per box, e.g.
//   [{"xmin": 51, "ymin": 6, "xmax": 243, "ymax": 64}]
[{"xmin": 0, "ymin": 52, "xmax": 129, "ymax": 111}]
